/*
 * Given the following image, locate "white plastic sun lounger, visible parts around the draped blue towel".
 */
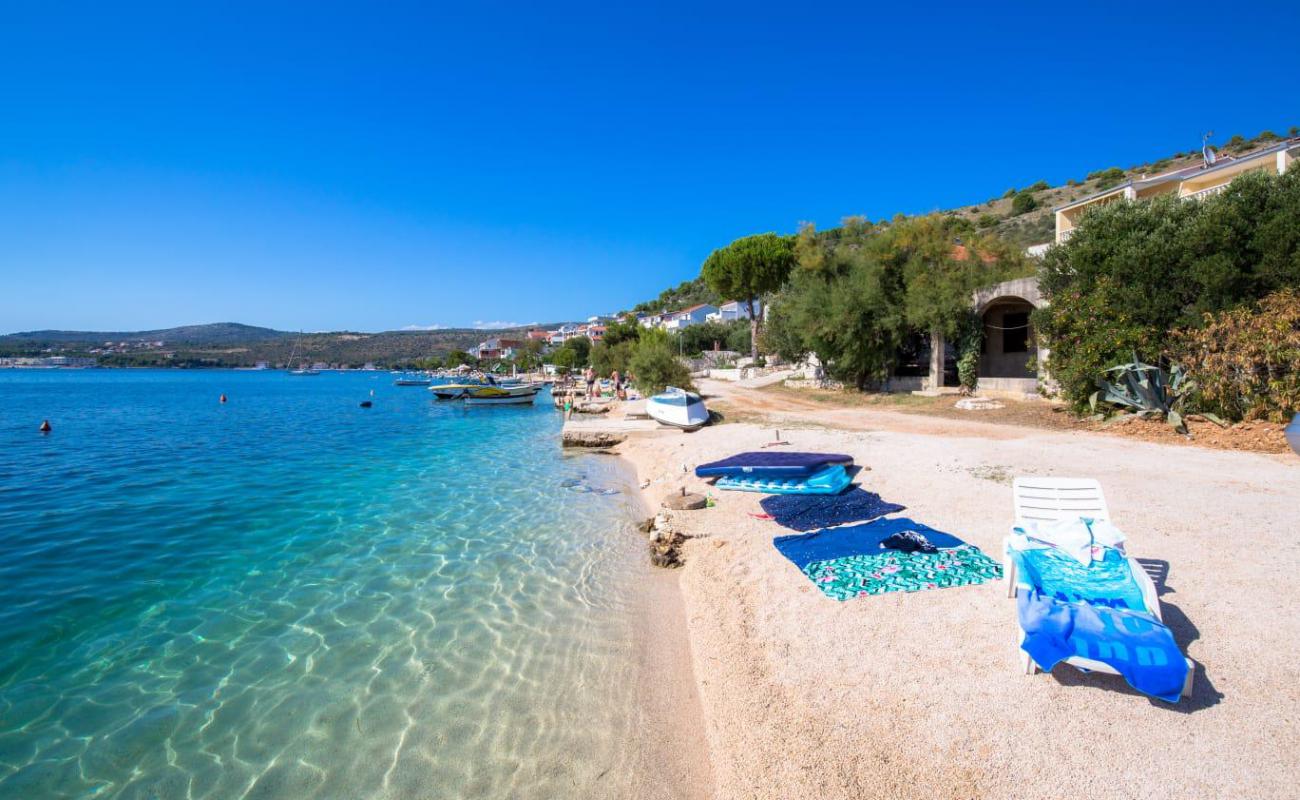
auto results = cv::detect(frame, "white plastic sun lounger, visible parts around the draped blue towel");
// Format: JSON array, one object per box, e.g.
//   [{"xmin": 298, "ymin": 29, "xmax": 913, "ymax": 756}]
[{"xmin": 1002, "ymin": 477, "xmax": 1196, "ymax": 697}]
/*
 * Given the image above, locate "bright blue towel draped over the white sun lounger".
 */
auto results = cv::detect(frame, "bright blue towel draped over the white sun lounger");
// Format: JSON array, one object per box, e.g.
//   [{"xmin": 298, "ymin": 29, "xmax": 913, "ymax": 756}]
[{"xmin": 1017, "ymin": 588, "xmax": 1187, "ymax": 702}]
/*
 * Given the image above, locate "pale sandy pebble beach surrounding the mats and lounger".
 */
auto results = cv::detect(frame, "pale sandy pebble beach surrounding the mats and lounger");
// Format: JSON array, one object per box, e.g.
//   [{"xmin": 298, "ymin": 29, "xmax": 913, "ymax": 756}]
[{"xmin": 619, "ymin": 385, "xmax": 1300, "ymax": 800}]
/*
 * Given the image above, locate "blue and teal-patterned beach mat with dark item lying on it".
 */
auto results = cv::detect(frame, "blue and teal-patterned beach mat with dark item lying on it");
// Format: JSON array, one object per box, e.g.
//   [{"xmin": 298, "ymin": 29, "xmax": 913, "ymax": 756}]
[{"xmin": 772, "ymin": 518, "xmax": 1002, "ymax": 600}]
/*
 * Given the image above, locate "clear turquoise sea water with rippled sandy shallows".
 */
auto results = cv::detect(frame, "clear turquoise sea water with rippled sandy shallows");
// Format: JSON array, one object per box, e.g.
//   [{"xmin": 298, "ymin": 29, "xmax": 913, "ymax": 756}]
[{"xmin": 0, "ymin": 371, "xmax": 646, "ymax": 800}]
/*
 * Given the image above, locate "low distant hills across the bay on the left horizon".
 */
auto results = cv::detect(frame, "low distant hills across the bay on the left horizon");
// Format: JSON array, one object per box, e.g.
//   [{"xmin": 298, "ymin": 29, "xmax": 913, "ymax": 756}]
[{"xmin": 0, "ymin": 323, "xmax": 574, "ymax": 367}]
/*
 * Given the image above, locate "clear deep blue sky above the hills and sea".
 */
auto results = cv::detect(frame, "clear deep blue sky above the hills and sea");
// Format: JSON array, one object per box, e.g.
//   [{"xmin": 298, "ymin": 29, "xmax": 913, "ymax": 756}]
[{"xmin": 0, "ymin": 1, "xmax": 1300, "ymax": 332}]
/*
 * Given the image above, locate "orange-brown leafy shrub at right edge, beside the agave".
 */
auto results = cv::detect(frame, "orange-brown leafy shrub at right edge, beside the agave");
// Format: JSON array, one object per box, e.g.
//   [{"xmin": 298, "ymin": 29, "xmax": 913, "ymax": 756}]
[{"xmin": 1173, "ymin": 287, "xmax": 1300, "ymax": 423}]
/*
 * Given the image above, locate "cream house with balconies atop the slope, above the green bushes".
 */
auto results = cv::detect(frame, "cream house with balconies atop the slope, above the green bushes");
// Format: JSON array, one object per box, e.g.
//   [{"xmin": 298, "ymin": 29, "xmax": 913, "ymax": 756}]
[{"xmin": 1053, "ymin": 138, "xmax": 1300, "ymax": 245}]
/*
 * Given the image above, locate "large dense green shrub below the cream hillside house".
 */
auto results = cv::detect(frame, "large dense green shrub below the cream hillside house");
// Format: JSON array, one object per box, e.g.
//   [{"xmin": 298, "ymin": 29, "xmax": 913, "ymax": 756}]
[{"xmin": 1034, "ymin": 170, "xmax": 1300, "ymax": 416}]
